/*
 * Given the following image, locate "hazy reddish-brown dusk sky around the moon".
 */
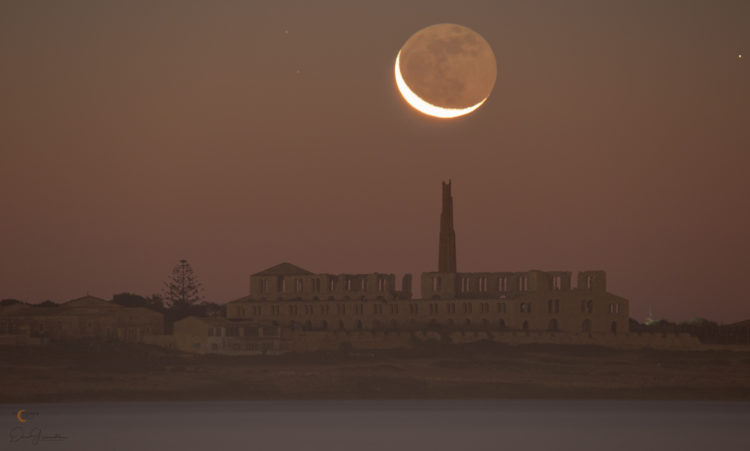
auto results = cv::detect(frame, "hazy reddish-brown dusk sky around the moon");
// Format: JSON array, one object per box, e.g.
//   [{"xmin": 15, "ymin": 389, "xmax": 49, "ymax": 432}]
[{"xmin": 0, "ymin": 0, "xmax": 750, "ymax": 322}]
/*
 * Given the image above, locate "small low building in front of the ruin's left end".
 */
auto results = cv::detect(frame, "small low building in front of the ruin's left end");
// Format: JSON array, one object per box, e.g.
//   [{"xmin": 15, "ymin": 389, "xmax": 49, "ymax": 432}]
[{"xmin": 173, "ymin": 316, "xmax": 288, "ymax": 355}]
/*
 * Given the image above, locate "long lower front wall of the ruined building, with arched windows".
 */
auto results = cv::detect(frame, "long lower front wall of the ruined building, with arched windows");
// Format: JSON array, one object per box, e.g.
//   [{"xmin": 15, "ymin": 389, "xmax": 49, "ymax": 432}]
[{"xmin": 227, "ymin": 289, "xmax": 628, "ymax": 333}]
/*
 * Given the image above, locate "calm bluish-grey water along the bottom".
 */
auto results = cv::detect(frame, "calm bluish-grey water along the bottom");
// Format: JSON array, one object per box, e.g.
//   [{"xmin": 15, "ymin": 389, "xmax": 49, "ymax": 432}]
[{"xmin": 0, "ymin": 401, "xmax": 750, "ymax": 451}]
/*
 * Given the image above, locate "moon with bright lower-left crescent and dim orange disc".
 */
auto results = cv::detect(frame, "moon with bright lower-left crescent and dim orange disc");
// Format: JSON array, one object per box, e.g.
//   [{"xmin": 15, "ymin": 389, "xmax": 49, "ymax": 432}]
[{"xmin": 394, "ymin": 24, "xmax": 497, "ymax": 118}]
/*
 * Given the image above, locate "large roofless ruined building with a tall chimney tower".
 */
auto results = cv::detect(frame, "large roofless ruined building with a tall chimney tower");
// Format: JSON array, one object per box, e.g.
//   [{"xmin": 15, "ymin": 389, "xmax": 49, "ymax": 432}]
[{"xmin": 227, "ymin": 181, "xmax": 628, "ymax": 333}]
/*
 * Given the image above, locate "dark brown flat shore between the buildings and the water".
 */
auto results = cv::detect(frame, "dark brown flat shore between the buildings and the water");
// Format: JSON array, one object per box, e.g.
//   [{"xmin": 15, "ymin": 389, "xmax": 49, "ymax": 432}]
[{"xmin": 0, "ymin": 343, "xmax": 750, "ymax": 403}]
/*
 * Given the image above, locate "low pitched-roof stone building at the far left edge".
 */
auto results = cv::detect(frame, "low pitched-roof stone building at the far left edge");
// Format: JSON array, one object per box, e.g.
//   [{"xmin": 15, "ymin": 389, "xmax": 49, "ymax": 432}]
[{"xmin": 0, "ymin": 296, "xmax": 164, "ymax": 342}]
